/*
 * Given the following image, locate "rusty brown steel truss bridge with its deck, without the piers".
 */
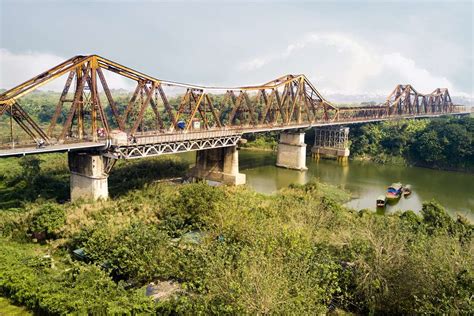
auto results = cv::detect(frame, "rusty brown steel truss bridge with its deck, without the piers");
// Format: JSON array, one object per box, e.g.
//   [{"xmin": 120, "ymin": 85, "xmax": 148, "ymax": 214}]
[{"xmin": 0, "ymin": 55, "xmax": 466, "ymax": 158}]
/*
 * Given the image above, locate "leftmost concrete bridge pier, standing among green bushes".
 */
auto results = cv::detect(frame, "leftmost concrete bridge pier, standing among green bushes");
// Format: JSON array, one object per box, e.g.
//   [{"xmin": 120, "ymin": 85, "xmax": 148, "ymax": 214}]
[{"xmin": 68, "ymin": 152, "xmax": 109, "ymax": 201}]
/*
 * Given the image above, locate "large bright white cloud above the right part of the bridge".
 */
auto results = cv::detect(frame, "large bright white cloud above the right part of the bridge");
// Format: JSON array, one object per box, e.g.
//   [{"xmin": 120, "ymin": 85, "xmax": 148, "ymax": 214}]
[{"xmin": 237, "ymin": 33, "xmax": 468, "ymax": 96}]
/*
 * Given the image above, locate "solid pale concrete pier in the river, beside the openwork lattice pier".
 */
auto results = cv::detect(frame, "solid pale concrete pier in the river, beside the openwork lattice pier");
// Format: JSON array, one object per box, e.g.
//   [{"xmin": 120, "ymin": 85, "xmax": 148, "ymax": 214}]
[{"xmin": 276, "ymin": 132, "xmax": 308, "ymax": 171}]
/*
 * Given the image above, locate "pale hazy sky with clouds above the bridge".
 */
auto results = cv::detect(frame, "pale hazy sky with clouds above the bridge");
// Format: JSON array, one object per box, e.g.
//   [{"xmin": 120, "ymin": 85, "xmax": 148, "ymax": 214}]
[{"xmin": 0, "ymin": 0, "xmax": 474, "ymax": 96}]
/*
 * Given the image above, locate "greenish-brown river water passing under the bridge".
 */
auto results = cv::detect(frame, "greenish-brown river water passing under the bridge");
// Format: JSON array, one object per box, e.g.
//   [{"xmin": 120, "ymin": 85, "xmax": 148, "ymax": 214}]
[{"xmin": 179, "ymin": 150, "xmax": 474, "ymax": 221}]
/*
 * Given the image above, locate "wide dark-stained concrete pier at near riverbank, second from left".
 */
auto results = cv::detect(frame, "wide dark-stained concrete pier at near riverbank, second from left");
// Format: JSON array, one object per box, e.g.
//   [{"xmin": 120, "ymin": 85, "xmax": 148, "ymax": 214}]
[{"xmin": 189, "ymin": 146, "xmax": 245, "ymax": 185}]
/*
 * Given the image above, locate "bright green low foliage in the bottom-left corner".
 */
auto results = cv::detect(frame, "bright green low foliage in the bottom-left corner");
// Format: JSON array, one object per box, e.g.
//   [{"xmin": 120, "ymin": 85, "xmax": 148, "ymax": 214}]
[{"xmin": 0, "ymin": 240, "xmax": 153, "ymax": 315}]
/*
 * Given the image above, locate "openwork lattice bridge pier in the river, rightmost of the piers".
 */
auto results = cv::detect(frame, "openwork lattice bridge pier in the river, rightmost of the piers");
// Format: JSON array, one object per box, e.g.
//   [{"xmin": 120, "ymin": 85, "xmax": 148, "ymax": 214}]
[{"xmin": 311, "ymin": 126, "xmax": 350, "ymax": 161}]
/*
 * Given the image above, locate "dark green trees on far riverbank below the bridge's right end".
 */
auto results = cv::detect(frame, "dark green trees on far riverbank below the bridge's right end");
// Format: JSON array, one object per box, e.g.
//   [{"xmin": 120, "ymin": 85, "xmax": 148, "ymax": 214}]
[{"xmin": 350, "ymin": 117, "xmax": 474, "ymax": 171}]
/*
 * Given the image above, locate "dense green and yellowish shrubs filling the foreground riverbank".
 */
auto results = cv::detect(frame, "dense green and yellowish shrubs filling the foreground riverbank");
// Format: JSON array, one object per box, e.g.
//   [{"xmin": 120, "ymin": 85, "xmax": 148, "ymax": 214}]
[{"xmin": 0, "ymin": 158, "xmax": 474, "ymax": 314}]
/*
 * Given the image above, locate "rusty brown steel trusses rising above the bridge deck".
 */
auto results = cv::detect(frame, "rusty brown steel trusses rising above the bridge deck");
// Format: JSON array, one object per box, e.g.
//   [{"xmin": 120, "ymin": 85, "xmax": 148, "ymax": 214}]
[{"xmin": 0, "ymin": 55, "xmax": 462, "ymax": 151}]
